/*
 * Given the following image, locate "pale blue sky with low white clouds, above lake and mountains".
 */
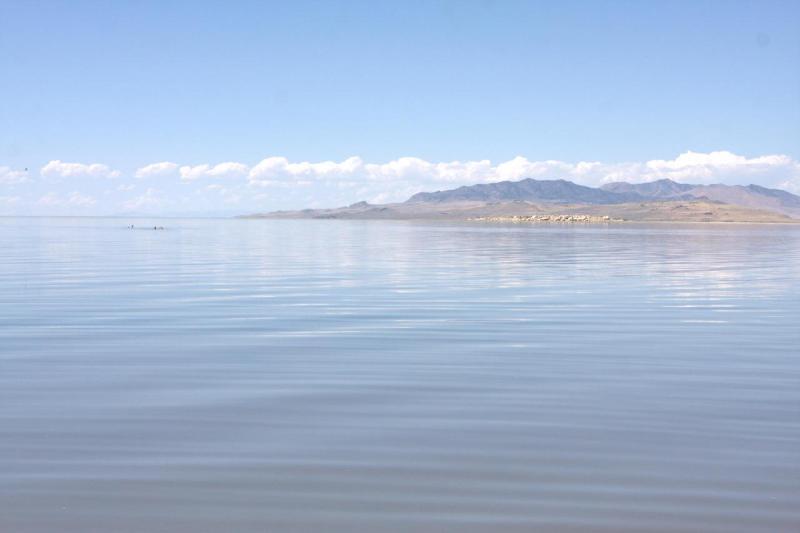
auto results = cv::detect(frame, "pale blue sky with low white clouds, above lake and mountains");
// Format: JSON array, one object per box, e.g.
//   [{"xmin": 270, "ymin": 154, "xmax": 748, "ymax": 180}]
[{"xmin": 0, "ymin": 0, "xmax": 800, "ymax": 215}]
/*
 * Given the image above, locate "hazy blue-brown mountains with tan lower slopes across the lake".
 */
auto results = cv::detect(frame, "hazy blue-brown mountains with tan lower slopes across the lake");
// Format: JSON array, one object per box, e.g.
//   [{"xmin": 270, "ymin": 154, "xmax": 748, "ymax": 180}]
[{"xmin": 250, "ymin": 178, "xmax": 800, "ymax": 222}]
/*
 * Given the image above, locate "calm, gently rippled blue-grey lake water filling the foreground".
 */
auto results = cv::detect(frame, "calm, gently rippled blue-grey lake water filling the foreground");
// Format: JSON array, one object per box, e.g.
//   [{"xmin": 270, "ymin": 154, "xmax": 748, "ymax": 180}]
[{"xmin": 0, "ymin": 218, "xmax": 800, "ymax": 533}]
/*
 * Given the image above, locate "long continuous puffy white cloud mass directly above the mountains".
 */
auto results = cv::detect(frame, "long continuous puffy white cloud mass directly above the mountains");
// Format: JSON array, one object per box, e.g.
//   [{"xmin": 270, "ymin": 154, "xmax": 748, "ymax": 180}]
[{"xmin": 248, "ymin": 151, "xmax": 800, "ymax": 205}]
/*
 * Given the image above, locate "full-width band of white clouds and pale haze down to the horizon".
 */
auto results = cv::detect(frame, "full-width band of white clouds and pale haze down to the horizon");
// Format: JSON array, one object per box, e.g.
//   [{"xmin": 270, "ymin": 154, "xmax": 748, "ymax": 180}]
[{"xmin": 0, "ymin": 151, "xmax": 800, "ymax": 214}]
